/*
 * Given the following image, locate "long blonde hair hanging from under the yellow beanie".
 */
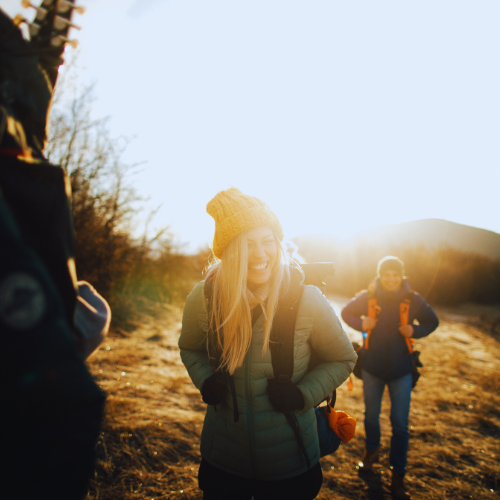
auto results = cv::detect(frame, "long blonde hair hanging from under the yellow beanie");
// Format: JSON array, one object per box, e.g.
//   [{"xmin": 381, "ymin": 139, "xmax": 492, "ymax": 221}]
[{"xmin": 206, "ymin": 232, "xmax": 290, "ymax": 375}]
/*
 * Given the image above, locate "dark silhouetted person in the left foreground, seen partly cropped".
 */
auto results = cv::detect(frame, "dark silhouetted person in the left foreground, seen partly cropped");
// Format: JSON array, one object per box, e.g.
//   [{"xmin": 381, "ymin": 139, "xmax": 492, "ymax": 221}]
[{"xmin": 0, "ymin": 7, "xmax": 110, "ymax": 500}]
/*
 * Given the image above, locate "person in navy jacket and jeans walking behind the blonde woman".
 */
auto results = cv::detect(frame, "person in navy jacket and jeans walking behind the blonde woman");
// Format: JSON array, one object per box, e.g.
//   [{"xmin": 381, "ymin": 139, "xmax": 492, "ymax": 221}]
[{"xmin": 342, "ymin": 256, "xmax": 439, "ymax": 498}]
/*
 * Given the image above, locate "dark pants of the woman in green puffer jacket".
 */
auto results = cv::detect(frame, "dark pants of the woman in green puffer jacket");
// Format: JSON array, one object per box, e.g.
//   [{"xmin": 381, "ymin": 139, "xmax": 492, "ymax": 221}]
[{"xmin": 198, "ymin": 459, "xmax": 323, "ymax": 500}]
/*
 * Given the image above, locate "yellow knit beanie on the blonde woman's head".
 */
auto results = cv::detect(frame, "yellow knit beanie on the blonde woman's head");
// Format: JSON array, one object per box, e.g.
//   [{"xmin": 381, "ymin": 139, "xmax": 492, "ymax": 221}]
[{"xmin": 207, "ymin": 188, "xmax": 283, "ymax": 259}]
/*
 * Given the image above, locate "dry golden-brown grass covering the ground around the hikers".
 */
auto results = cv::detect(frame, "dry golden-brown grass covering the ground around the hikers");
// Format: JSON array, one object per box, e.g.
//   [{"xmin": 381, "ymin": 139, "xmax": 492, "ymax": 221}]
[{"xmin": 88, "ymin": 299, "xmax": 500, "ymax": 500}]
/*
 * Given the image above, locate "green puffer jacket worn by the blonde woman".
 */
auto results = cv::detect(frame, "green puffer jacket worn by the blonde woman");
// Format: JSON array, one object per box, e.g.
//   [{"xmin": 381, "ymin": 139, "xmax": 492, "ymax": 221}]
[{"xmin": 179, "ymin": 281, "xmax": 356, "ymax": 480}]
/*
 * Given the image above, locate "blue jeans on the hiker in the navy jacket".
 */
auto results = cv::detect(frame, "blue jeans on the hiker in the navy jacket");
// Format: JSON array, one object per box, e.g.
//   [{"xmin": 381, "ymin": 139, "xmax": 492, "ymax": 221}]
[{"xmin": 363, "ymin": 370, "xmax": 412, "ymax": 474}]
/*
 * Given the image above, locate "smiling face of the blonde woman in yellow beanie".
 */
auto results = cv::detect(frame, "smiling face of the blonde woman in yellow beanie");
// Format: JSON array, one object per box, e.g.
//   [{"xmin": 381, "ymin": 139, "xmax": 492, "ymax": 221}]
[{"xmin": 247, "ymin": 226, "xmax": 278, "ymax": 288}]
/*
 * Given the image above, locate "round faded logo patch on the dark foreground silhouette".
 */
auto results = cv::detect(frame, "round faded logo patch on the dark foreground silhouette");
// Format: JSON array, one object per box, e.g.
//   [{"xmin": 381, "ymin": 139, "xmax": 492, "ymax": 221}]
[{"xmin": 0, "ymin": 273, "xmax": 47, "ymax": 330}]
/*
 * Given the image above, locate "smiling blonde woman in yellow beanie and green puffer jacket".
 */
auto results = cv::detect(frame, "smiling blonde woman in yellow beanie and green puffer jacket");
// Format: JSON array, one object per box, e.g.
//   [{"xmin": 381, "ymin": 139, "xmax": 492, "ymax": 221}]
[{"xmin": 179, "ymin": 188, "xmax": 356, "ymax": 500}]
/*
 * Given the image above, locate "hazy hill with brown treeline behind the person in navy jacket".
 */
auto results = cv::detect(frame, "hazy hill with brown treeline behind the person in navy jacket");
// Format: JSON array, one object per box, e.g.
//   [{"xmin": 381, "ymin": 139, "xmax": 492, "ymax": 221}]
[{"xmin": 293, "ymin": 219, "xmax": 500, "ymax": 305}]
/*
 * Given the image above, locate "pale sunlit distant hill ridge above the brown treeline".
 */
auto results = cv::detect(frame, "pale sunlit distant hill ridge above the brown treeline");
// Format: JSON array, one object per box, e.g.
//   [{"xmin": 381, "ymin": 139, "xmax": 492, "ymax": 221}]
[{"xmin": 293, "ymin": 219, "xmax": 500, "ymax": 259}]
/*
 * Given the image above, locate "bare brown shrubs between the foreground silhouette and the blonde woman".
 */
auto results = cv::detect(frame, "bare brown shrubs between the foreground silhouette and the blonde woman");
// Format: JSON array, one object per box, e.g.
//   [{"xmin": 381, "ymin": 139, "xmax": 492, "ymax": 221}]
[{"xmin": 45, "ymin": 85, "xmax": 209, "ymax": 331}]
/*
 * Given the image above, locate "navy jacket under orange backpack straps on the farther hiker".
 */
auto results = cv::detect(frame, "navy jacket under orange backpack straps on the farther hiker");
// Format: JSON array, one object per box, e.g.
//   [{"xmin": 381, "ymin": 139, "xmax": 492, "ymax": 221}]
[{"xmin": 342, "ymin": 279, "xmax": 439, "ymax": 381}]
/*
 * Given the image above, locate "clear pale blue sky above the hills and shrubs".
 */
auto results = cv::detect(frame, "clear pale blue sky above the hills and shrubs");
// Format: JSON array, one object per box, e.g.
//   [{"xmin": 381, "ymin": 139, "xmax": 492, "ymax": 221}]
[{"xmin": 0, "ymin": 0, "xmax": 500, "ymax": 249}]
